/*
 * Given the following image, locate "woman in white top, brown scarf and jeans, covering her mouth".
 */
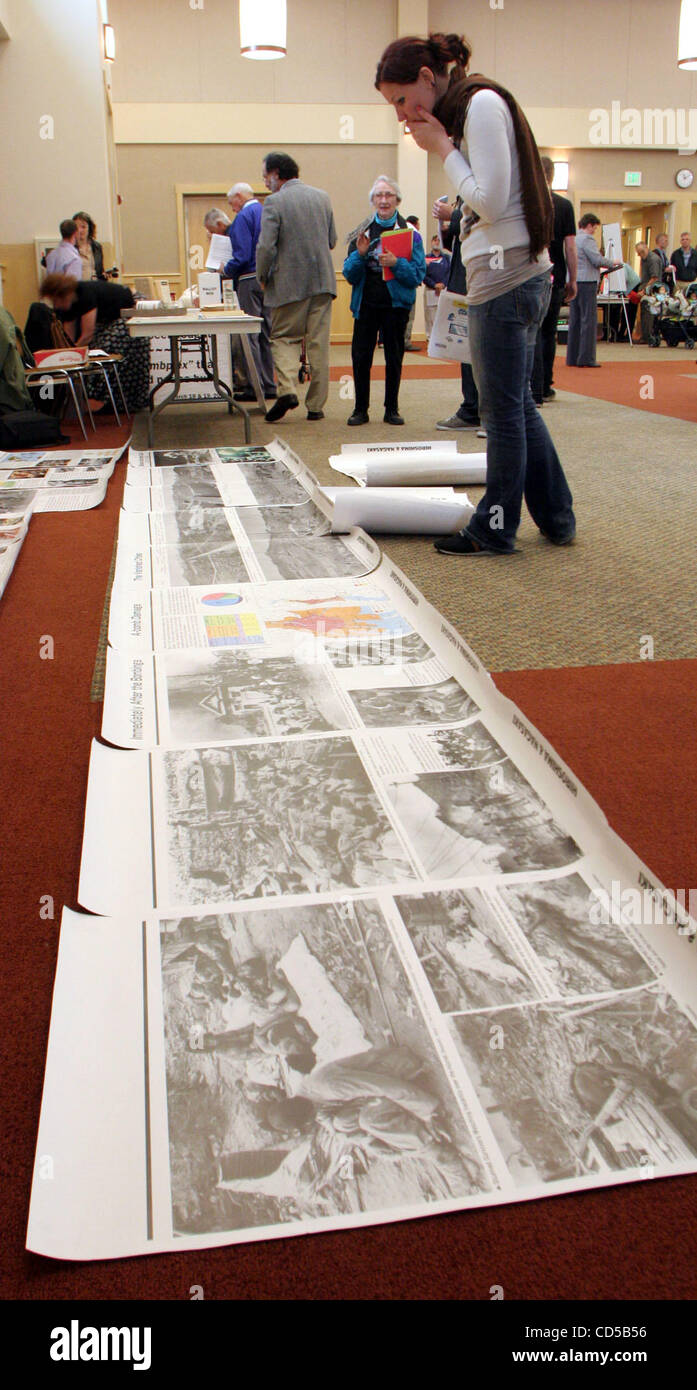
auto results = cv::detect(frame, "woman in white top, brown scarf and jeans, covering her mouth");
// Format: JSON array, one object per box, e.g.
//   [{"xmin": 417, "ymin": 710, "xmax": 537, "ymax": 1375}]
[{"xmin": 376, "ymin": 33, "xmax": 576, "ymax": 555}]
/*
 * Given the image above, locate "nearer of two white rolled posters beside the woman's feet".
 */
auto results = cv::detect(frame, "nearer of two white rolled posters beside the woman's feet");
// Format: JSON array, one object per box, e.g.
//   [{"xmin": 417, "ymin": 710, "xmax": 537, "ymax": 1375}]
[{"xmin": 331, "ymin": 488, "xmax": 474, "ymax": 535}]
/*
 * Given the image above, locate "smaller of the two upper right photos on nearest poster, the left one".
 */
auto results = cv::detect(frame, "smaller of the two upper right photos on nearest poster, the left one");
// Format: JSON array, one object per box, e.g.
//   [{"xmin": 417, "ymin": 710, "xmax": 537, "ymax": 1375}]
[{"xmin": 395, "ymin": 888, "xmax": 538, "ymax": 1013}]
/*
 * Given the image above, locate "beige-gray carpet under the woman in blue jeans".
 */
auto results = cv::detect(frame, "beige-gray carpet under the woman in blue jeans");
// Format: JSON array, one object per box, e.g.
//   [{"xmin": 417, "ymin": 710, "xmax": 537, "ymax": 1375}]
[{"xmin": 132, "ymin": 369, "xmax": 697, "ymax": 670}]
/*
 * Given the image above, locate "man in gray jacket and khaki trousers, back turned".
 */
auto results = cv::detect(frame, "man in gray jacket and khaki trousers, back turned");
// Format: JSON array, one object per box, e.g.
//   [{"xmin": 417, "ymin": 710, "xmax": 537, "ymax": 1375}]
[{"xmin": 256, "ymin": 152, "xmax": 337, "ymax": 421}]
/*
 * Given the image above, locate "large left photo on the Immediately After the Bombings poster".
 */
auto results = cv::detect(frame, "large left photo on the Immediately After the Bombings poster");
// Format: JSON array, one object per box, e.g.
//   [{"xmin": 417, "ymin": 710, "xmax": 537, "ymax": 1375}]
[{"xmin": 160, "ymin": 652, "xmax": 351, "ymax": 744}]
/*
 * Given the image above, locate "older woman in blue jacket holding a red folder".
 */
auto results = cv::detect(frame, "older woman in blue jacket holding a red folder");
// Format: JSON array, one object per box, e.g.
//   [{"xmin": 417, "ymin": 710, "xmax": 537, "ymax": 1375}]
[{"xmin": 344, "ymin": 174, "xmax": 426, "ymax": 425}]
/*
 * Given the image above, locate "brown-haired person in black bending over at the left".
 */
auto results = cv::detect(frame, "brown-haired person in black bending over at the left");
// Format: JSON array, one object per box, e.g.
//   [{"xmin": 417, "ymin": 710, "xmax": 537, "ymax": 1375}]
[{"xmin": 40, "ymin": 275, "xmax": 150, "ymax": 413}]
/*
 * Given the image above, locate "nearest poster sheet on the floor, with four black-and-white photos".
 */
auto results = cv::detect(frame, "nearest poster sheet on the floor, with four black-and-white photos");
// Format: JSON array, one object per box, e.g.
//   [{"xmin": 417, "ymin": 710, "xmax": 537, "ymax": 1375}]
[{"xmin": 28, "ymin": 845, "xmax": 697, "ymax": 1259}]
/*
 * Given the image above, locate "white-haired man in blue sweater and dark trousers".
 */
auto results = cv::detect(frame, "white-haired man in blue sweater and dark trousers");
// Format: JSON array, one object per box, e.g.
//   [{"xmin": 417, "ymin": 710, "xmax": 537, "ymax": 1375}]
[{"xmin": 217, "ymin": 183, "xmax": 275, "ymax": 400}]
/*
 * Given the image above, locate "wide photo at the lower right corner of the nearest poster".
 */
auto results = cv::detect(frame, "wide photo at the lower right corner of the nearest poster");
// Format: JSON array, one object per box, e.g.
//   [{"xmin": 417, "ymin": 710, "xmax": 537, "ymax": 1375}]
[{"xmin": 448, "ymin": 987, "xmax": 697, "ymax": 1186}]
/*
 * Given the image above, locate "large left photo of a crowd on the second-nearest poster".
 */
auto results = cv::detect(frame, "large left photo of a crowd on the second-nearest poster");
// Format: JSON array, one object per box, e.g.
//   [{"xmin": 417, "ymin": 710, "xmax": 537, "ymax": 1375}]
[{"xmin": 163, "ymin": 737, "xmax": 415, "ymax": 904}]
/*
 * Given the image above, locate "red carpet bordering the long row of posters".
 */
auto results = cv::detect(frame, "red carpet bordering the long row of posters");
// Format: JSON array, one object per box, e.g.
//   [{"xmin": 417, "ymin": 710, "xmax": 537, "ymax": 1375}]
[{"xmin": 0, "ymin": 417, "xmax": 697, "ymax": 1301}]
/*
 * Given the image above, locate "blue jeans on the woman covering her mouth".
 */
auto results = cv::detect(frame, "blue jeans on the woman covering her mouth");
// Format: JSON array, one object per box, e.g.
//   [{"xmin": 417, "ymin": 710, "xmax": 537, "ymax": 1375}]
[{"xmin": 466, "ymin": 271, "xmax": 576, "ymax": 552}]
